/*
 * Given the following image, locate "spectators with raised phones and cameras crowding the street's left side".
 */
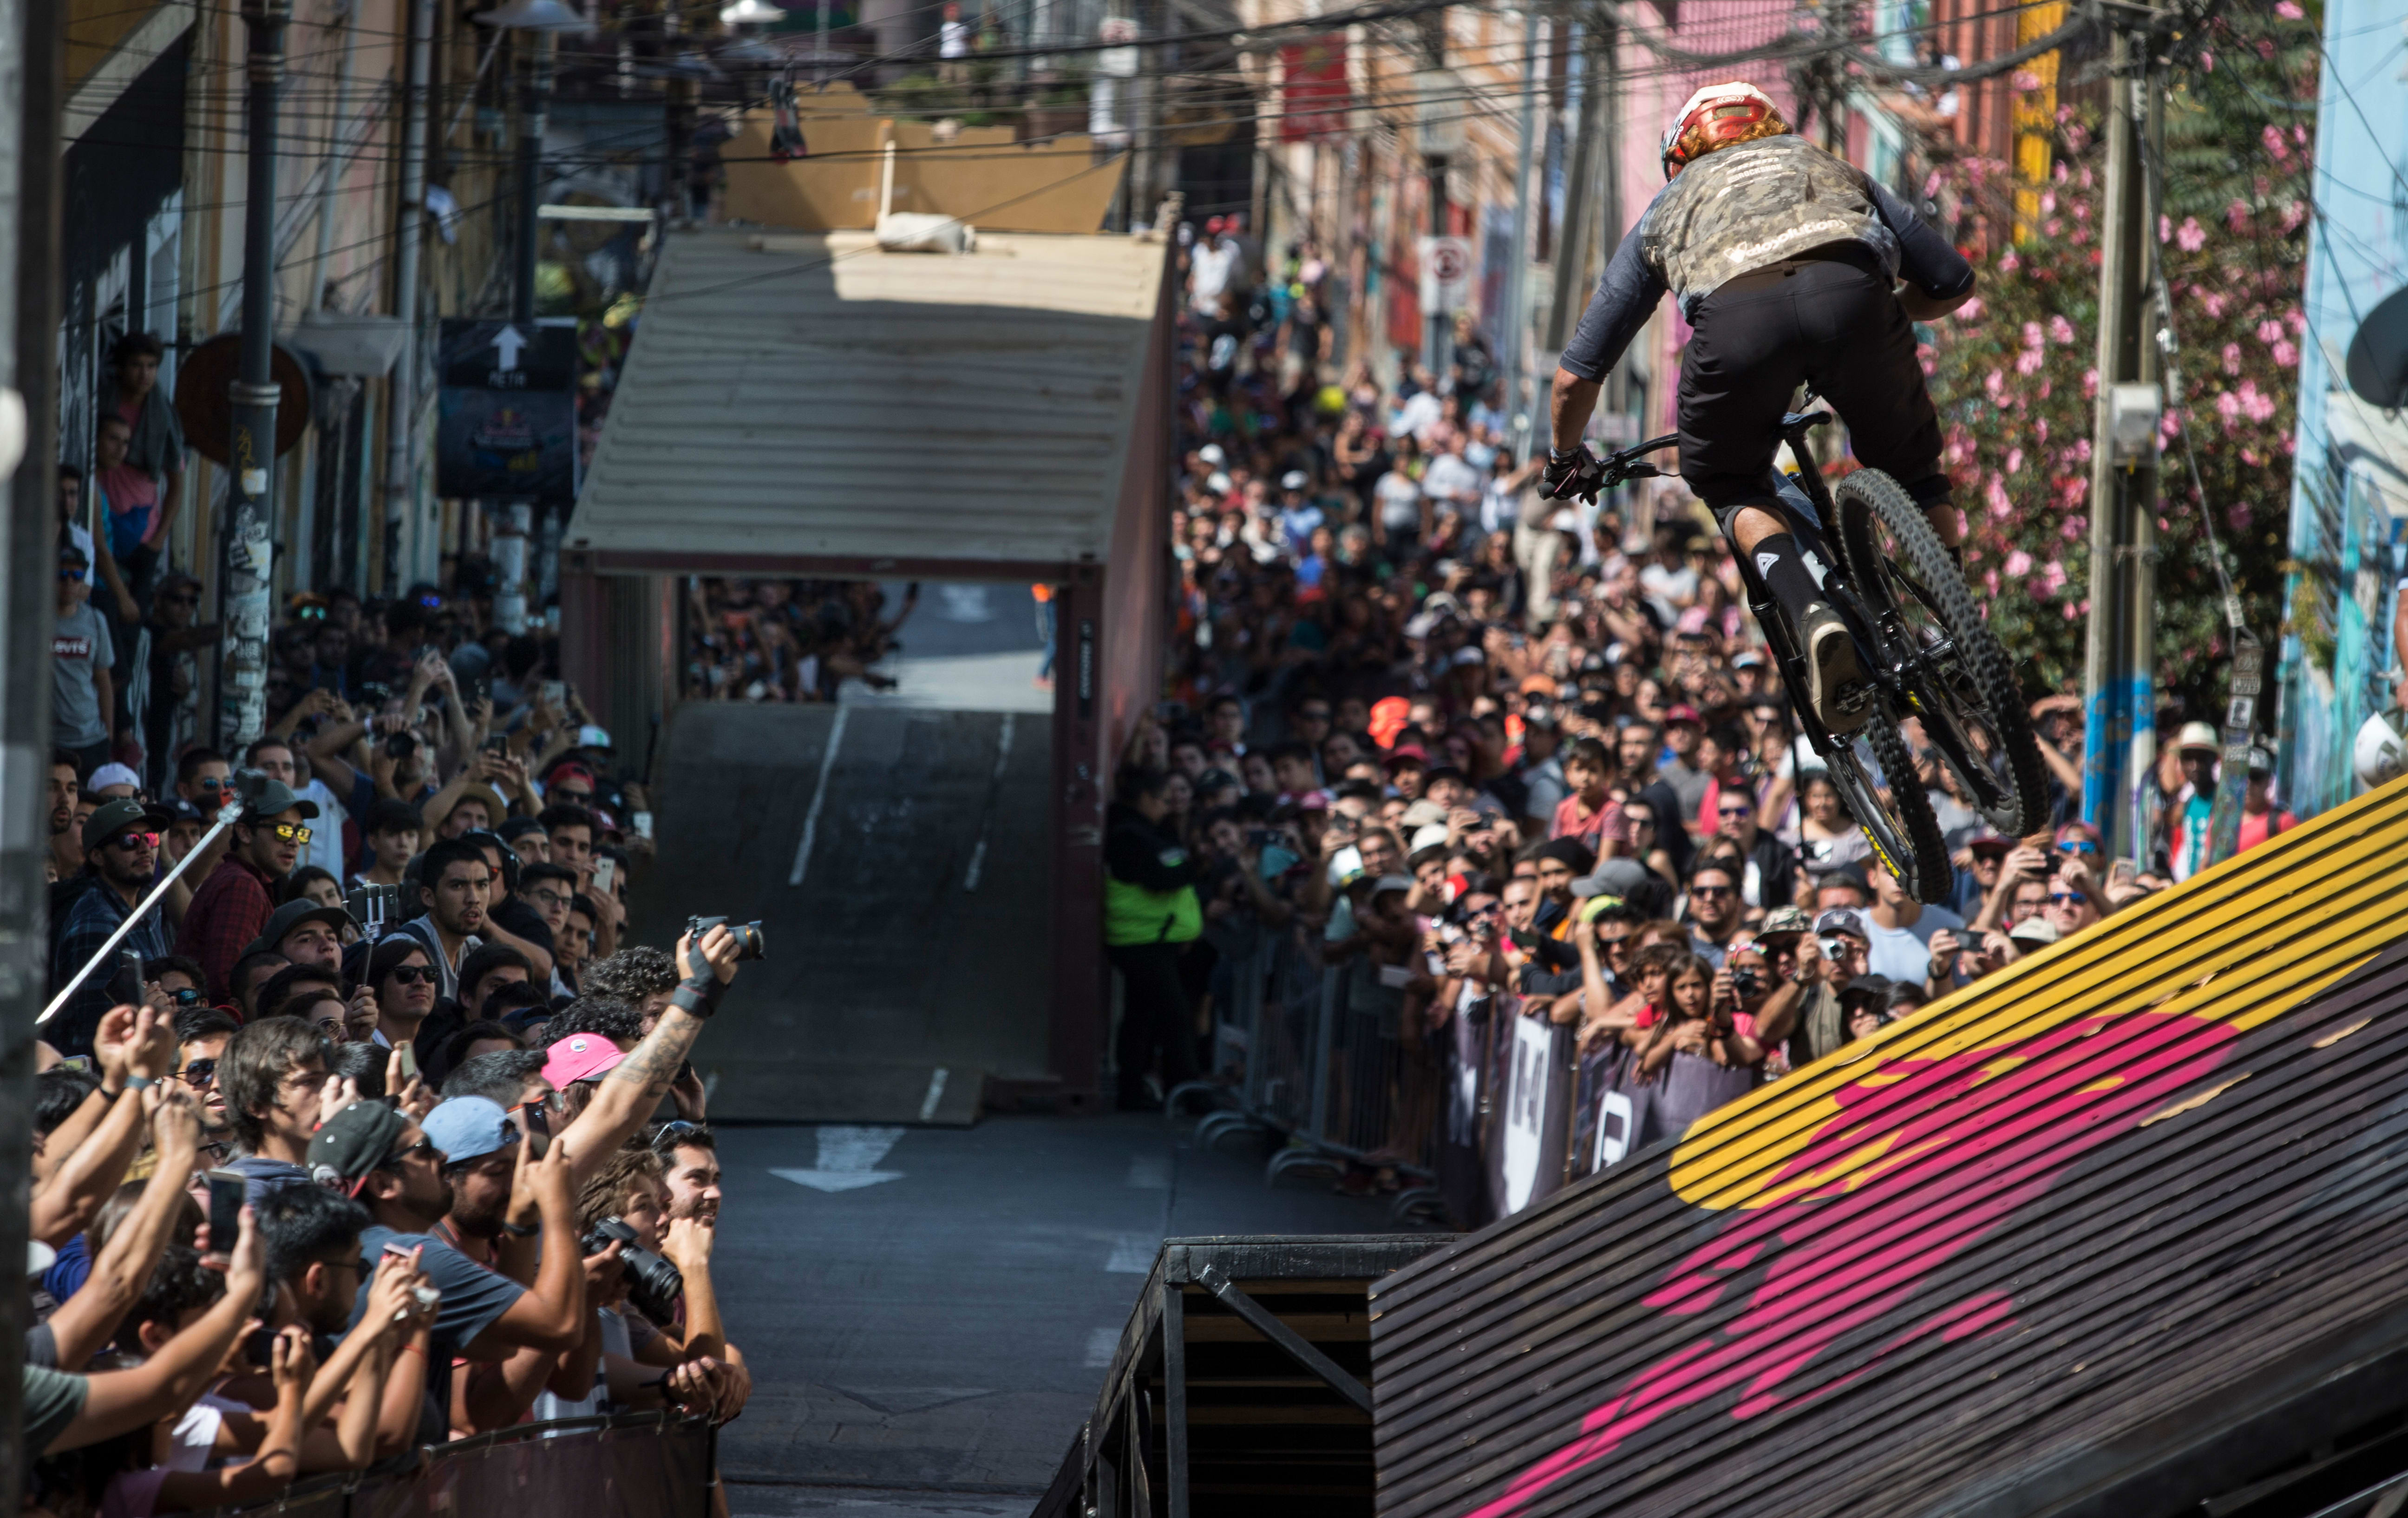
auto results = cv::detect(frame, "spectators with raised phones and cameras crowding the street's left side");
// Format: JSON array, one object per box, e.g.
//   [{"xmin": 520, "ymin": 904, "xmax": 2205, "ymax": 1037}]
[{"xmin": 24, "ymin": 335, "xmax": 768, "ymax": 1516}]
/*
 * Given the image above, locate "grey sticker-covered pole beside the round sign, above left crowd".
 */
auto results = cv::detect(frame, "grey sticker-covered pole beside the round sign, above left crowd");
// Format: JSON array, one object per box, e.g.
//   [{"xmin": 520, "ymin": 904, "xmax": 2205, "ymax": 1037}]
[{"xmin": 217, "ymin": 0, "xmax": 294, "ymax": 749}]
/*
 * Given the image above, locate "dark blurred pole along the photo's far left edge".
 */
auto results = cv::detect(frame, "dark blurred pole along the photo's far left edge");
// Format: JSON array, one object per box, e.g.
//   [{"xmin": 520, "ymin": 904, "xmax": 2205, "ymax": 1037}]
[{"xmin": 0, "ymin": 0, "xmax": 67, "ymax": 1511}]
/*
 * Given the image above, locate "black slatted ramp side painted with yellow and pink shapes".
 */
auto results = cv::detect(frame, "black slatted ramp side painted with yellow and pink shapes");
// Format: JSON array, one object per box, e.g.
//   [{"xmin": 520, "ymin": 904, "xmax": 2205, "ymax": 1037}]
[{"xmin": 1373, "ymin": 783, "xmax": 2408, "ymax": 1518}]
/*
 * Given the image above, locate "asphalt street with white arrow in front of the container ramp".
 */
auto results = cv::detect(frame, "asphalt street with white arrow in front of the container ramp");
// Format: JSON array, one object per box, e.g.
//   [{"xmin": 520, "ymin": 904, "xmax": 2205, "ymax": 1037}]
[{"xmin": 713, "ymin": 1116, "xmax": 1394, "ymax": 1518}]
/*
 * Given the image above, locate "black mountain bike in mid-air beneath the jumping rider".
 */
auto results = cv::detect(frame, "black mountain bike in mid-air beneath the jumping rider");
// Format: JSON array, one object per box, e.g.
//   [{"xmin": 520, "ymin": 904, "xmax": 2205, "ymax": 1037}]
[{"xmin": 1582, "ymin": 412, "xmax": 2047, "ymax": 903}]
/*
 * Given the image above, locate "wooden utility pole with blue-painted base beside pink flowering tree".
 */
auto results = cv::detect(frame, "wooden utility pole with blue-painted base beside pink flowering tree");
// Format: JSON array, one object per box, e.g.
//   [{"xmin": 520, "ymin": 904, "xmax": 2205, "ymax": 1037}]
[{"xmin": 2083, "ymin": 31, "xmax": 2162, "ymax": 858}]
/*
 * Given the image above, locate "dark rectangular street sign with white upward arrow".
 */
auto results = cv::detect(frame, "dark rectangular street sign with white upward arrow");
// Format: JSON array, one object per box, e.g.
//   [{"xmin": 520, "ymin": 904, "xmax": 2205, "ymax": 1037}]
[{"xmin": 436, "ymin": 321, "xmax": 578, "ymax": 506}]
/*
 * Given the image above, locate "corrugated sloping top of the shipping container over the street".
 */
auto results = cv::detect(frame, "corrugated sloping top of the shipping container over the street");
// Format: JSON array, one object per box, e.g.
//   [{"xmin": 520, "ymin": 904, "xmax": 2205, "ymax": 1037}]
[{"xmin": 563, "ymin": 229, "xmax": 1165, "ymax": 574}]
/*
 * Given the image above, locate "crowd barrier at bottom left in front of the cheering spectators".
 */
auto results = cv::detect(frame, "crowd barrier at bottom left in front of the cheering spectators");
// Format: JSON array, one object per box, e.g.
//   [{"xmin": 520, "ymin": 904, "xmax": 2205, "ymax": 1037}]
[{"xmin": 198, "ymin": 1412, "xmax": 718, "ymax": 1518}]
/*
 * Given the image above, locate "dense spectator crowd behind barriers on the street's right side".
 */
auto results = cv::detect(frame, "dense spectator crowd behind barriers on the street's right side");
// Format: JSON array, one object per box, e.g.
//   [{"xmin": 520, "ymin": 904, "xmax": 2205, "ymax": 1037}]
[{"xmin": 1105, "ymin": 219, "xmax": 2295, "ymax": 1222}]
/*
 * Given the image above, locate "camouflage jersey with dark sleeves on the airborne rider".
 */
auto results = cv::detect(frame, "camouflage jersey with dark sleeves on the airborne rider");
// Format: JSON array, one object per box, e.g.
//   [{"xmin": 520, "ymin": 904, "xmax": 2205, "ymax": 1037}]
[{"xmin": 1563, "ymin": 135, "xmax": 1972, "ymax": 378}]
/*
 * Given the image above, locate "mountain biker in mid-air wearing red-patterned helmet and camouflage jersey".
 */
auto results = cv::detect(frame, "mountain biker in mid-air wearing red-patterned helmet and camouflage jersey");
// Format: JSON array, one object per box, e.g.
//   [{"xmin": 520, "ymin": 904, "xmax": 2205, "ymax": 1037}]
[{"xmin": 1541, "ymin": 82, "xmax": 1975, "ymax": 733}]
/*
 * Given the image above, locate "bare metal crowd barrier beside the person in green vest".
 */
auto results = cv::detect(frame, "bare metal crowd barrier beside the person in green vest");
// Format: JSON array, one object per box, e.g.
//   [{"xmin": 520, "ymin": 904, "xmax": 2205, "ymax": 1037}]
[{"xmin": 1165, "ymin": 928, "xmax": 1440, "ymax": 1219}]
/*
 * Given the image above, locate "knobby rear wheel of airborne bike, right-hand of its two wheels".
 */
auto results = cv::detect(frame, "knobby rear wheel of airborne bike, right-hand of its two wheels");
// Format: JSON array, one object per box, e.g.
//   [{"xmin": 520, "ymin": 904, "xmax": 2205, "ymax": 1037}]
[{"xmin": 1832, "ymin": 470, "xmax": 2049, "ymax": 838}]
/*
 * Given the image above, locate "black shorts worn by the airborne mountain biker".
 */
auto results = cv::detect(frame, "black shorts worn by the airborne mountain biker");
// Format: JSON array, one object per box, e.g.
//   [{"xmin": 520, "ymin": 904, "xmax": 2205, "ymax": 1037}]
[{"xmin": 1681, "ymin": 250, "xmax": 1948, "ymax": 518}]
